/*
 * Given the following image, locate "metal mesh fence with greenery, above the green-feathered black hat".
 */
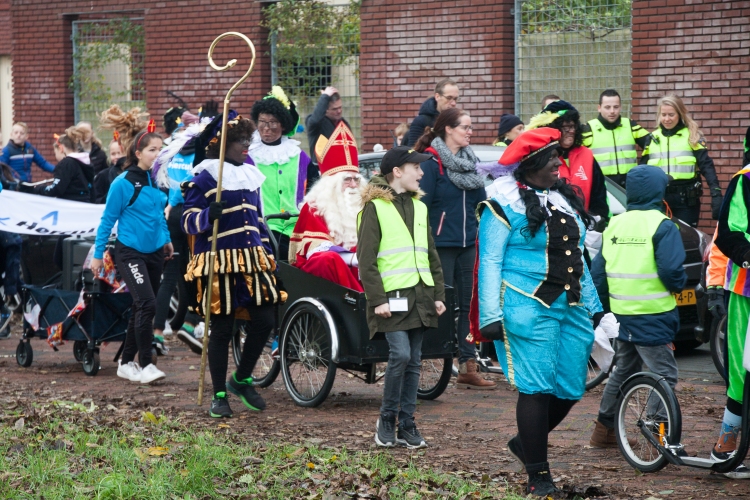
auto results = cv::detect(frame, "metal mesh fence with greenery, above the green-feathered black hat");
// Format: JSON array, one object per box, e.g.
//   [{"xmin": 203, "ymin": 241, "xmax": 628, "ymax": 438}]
[{"xmin": 271, "ymin": 2, "xmax": 362, "ymax": 151}]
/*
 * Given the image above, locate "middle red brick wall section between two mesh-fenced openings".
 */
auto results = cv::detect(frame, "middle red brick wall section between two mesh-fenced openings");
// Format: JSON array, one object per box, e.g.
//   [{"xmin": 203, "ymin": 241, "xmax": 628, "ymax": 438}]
[{"xmin": 359, "ymin": 0, "xmax": 514, "ymax": 150}]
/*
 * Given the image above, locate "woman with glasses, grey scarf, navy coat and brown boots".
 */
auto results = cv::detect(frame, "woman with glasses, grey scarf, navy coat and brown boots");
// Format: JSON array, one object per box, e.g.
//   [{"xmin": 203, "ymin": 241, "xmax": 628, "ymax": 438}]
[{"xmin": 414, "ymin": 108, "xmax": 497, "ymax": 389}]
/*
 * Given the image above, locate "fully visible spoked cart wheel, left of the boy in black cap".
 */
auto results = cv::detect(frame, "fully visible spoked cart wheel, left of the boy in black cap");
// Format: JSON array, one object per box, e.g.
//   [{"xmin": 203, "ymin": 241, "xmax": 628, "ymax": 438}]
[{"xmin": 280, "ymin": 302, "xmax": 336, "ymax": 407}]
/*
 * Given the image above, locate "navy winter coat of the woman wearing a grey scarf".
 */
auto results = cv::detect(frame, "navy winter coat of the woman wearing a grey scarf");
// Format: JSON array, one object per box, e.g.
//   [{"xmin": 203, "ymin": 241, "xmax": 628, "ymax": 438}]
[{"xmin": 419, "ymin": 152, "xmax": 487, "ymax": 248}]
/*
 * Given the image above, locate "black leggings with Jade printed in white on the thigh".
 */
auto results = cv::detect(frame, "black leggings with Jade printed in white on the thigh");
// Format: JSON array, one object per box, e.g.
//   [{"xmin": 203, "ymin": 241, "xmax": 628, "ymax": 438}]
[{"xmin": 115, "ymin": 241, "xmax": 164, "ymax": 368}]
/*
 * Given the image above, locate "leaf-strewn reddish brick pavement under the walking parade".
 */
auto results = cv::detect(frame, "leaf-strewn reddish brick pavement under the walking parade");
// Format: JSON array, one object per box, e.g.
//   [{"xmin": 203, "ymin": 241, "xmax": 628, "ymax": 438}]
[{"xmin": 0, "ymin": 320, "xmax": 750, "ymax": 500}]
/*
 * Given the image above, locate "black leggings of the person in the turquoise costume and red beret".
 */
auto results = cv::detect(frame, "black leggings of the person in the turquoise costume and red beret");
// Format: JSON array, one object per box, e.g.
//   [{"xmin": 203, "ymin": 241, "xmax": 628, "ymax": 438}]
[{"xmin": 516, "ymin": 393, "xmax": 578, "ymax": 464}]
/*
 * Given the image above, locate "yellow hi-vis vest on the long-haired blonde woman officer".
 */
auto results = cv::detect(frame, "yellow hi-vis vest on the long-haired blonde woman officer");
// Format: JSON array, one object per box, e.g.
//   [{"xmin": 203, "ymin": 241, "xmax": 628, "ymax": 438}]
[{"xmin": 643, "ymin": 127, "xmax": 706, "ymax": 180}]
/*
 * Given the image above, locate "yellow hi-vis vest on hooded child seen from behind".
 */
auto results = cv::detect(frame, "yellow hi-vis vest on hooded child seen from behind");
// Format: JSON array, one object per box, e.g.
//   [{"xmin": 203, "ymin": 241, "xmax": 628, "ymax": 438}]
[{"xmin": 602, "ymin": 210, "xmax": 677, "ymax": 315}]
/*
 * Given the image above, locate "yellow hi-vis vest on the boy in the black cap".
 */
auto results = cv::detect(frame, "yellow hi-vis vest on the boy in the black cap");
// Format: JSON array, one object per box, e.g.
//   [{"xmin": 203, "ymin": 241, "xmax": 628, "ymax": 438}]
[{"xmin": 357, "ymin": 198, "xmax": 435, "ymax": 292}]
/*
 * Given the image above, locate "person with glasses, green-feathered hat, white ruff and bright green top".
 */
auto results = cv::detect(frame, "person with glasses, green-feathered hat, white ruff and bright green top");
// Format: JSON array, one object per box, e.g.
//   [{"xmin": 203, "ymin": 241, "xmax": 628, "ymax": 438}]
[{"xmin": 248, "ymin": 86, "xmax": 310, "ymax": 260}]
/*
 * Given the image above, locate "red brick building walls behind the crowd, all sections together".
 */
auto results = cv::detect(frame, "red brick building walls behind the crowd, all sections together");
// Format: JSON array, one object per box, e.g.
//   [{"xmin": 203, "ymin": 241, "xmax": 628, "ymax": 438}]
[{"xmin": 5, "ymin": 0, "xmax": 750, "ymax": 227}]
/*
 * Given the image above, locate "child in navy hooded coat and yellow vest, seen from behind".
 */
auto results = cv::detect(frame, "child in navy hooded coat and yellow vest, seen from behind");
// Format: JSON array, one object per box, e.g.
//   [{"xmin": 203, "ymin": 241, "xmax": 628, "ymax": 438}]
[{"xmin": 590, "ymin": 165, "xmax": 687, "ymax": 448}]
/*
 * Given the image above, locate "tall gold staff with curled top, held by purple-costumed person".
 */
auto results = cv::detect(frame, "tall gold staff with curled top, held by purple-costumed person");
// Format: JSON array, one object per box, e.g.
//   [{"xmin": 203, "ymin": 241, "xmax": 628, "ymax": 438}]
[{"xmin": 198, "ymin": 31, "xmax": 255, "ymax": 406}]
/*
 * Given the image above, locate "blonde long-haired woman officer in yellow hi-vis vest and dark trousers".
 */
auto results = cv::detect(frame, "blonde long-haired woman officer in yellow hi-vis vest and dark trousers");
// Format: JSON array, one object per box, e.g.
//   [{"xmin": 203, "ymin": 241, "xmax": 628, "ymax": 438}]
[{"xmin": 641, "ymin": 94, "xmax": 723, "ymax": 227}]
